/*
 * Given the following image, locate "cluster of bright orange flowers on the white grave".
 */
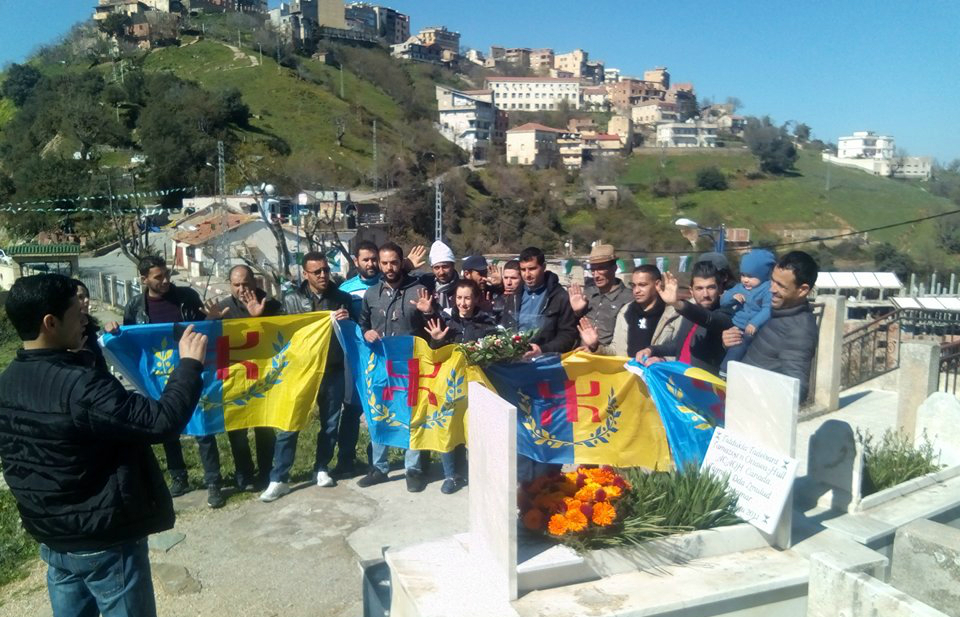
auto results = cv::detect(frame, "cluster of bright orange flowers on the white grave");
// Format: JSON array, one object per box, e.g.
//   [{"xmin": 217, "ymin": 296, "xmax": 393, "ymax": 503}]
[{"xmin": 519, "ymin": 466, "xmax": 631, "ymax": 546}]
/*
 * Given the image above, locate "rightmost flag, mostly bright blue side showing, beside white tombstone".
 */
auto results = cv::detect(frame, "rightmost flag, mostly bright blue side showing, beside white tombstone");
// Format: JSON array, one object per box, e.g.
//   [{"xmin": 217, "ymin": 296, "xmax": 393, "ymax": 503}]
[{"xmin": 626, "ymin": 360, "xmax": 727, "ymax": 468}]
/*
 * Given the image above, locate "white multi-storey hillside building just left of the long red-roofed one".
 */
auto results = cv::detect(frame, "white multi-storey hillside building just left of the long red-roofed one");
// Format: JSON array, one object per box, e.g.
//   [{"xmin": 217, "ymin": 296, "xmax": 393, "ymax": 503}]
[{"xmin": 436, "ymin": 86, "xmax": 497, "ymax": 160}]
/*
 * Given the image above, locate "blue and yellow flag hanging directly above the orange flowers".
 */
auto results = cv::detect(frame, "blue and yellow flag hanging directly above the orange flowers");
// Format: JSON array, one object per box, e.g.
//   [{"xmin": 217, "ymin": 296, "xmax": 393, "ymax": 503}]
[{"xmin": 484, "ymin": 352, "xmax": 671, "ymax": 470}]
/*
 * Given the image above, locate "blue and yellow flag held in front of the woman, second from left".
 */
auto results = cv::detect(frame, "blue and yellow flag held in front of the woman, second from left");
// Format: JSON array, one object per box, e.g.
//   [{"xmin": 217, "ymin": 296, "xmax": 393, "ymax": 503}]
[{"xmin": 337, "ymin": 321, "xmax": 467, "ymax": 452}]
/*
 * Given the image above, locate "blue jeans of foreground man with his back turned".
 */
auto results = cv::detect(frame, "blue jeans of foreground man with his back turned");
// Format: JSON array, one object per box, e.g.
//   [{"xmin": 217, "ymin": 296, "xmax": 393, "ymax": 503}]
[{"xmin": 40, "ymin": 538, "xmax": 157, "ymax": 617}]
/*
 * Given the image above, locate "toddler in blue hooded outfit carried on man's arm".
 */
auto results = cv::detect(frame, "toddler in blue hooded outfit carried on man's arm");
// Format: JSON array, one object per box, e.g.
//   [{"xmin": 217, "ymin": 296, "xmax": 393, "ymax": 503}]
[{"xmin": 720, "ymin": 249, "xmax": 777, "ymax": 373}]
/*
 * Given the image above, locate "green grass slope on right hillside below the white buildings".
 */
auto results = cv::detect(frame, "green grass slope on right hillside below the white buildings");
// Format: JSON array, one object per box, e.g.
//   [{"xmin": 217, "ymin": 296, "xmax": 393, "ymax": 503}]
[{"xmin": 620, "ymin": 150, "xmax": 956, "ymax": 251}]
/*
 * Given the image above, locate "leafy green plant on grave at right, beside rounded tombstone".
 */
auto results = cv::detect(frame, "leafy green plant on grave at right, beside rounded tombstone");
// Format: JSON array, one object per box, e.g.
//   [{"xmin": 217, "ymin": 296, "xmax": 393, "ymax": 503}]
[{"xmin": 857, "ymin": 429, "xmax": 943, "ymax": 495}]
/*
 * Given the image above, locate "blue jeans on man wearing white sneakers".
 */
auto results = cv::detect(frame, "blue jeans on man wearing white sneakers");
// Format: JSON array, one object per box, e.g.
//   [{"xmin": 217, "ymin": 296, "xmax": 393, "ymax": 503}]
[{"xmin": 270, "ymin": 368, "xmax": 344, "ymax": 482}]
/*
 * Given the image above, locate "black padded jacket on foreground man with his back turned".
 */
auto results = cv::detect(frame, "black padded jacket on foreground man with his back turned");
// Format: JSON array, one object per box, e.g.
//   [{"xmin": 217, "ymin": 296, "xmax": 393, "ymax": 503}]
[{"xmin": 0, "ymin": 350, "xmax": 203, "ymax": 552}]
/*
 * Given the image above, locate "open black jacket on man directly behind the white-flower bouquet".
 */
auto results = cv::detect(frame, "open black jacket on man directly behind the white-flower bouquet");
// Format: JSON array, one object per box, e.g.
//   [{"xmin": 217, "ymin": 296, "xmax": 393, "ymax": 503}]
[{"xmin": 500, "ymin": 272, "xmax": 580, "ymax": 353}]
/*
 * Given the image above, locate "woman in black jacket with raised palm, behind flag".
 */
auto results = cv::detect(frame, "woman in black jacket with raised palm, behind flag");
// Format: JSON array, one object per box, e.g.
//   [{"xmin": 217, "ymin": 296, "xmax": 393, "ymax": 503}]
[{"xmin": 424, "ymin": 279, "xmax": 497, "ymax": 495}]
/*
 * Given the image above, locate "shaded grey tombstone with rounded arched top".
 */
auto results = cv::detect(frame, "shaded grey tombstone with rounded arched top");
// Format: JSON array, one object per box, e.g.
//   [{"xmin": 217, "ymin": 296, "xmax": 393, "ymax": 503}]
[{"xmin": 807, "ymin": 420, "xmax": 863, "ymax": 512}]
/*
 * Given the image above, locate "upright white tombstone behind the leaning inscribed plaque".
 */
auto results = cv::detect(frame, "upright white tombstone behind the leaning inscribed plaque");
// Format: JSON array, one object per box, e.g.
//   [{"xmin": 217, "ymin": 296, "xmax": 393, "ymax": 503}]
[{"xmin": 724, "ymin": 362, "xmax": 800, "ymax": 548}]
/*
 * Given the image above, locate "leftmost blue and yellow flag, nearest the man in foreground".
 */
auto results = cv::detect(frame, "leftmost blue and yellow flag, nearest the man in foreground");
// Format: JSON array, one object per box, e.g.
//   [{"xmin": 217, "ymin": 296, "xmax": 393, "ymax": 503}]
[{"xmin": 102, "ymin": 311, "xmax": 332, "ymax": 435}]
